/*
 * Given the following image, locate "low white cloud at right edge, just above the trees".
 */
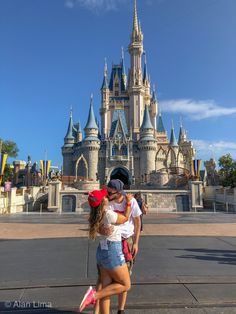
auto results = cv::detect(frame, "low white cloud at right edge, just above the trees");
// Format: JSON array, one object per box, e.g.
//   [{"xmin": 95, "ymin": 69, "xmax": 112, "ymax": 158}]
[{"xmin": 192, "ymin": 139, "xmax": 236, "ymax": 160}]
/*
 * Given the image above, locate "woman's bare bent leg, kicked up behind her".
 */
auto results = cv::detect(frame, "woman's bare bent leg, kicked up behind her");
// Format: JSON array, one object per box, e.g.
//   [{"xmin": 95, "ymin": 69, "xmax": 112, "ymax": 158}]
[{"xmin": 95, "ymin": 264, "xmax": 131, "ymax": 300}]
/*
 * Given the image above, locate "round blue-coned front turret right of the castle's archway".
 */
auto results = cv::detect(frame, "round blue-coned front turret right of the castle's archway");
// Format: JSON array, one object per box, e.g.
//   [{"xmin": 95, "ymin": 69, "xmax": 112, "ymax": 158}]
[{"xmin": 139, "ymin": 105, "xmax": 156, "ymax": 182}]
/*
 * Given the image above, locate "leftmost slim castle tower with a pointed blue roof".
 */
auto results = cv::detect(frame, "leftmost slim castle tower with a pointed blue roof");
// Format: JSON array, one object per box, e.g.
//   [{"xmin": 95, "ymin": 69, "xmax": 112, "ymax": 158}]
[{"xmin": 62, "ymin": 111, "xmax": 76, "ymax": 176}]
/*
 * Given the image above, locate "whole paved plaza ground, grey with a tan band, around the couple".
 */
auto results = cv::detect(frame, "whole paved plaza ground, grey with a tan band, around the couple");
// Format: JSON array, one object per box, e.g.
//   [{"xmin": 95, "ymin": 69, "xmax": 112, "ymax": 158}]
[{"xmin": 0, "ymin": 213, "xmax": 236, "ymax": 314}]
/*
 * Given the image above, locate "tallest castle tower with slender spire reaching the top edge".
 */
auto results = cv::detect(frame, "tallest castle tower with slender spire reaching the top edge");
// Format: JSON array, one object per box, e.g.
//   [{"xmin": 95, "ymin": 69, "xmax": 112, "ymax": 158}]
[{"xmin": 128, "ymin": 0, "xmax": 145, "ymax": 139}]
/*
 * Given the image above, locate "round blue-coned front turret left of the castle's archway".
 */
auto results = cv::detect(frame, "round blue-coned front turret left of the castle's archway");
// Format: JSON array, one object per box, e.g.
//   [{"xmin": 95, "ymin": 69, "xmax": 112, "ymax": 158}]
[{"xmin": 83, "ymin": 95, "xmax": 100, "ymax": 181}]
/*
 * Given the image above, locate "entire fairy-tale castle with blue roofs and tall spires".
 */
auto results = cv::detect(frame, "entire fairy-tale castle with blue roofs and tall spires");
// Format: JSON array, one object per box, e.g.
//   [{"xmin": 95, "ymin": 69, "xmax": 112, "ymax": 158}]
[{"xmin": 62, "ymin": 0, "xmax": 195, "ymax": 187}]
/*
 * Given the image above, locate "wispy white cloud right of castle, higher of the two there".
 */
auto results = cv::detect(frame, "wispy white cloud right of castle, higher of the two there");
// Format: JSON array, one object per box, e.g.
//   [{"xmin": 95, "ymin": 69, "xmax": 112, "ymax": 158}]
[{"xmin": 160, "ymin": 99, "xmax": 236, "ymax": 120}]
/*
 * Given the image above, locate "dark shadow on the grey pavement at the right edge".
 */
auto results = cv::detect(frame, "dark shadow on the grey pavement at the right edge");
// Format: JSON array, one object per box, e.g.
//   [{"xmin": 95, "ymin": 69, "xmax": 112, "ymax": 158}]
[{"xmin": 170, "ymin": 249, "xmax": 236, "ymax": 265}]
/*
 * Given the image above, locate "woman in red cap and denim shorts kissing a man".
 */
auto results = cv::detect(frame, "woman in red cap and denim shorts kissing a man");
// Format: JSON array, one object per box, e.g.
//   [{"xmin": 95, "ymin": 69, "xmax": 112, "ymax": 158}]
[{"xmin": 80, "ymin": 189, "xmax": 133, "ymax": 314}]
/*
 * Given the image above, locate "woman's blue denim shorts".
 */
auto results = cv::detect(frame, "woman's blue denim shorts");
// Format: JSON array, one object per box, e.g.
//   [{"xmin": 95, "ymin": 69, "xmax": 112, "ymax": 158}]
[{"xmin": 96, "ymin": 241, "xmax": 125, "ymax": 269}]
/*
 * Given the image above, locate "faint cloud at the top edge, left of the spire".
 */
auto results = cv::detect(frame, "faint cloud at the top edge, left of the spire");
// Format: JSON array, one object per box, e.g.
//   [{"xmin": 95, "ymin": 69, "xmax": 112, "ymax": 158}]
[{"xmin": 65, "ymin": 0, "xmax": 127, "ymax": 12}]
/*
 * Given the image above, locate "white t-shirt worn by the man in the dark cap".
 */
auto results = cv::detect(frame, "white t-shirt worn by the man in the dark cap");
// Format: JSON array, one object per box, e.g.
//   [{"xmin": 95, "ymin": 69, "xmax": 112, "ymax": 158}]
[{"xmin": 108, "ymin": 197, "xmax": 142, "ymax": 239}]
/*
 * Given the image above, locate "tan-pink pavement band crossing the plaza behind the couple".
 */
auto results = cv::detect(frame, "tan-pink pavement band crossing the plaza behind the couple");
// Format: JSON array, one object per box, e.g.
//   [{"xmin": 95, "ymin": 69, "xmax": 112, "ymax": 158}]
[{"xmin": 0, "ymin": 223, "xmax": 236, "ymax": 239}]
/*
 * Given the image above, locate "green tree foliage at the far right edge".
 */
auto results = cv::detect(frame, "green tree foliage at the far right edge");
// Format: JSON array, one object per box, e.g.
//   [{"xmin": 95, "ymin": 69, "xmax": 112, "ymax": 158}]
[{"xmin": 219, "ymin": 154, "xmax": 236, "ymax": 188}]
